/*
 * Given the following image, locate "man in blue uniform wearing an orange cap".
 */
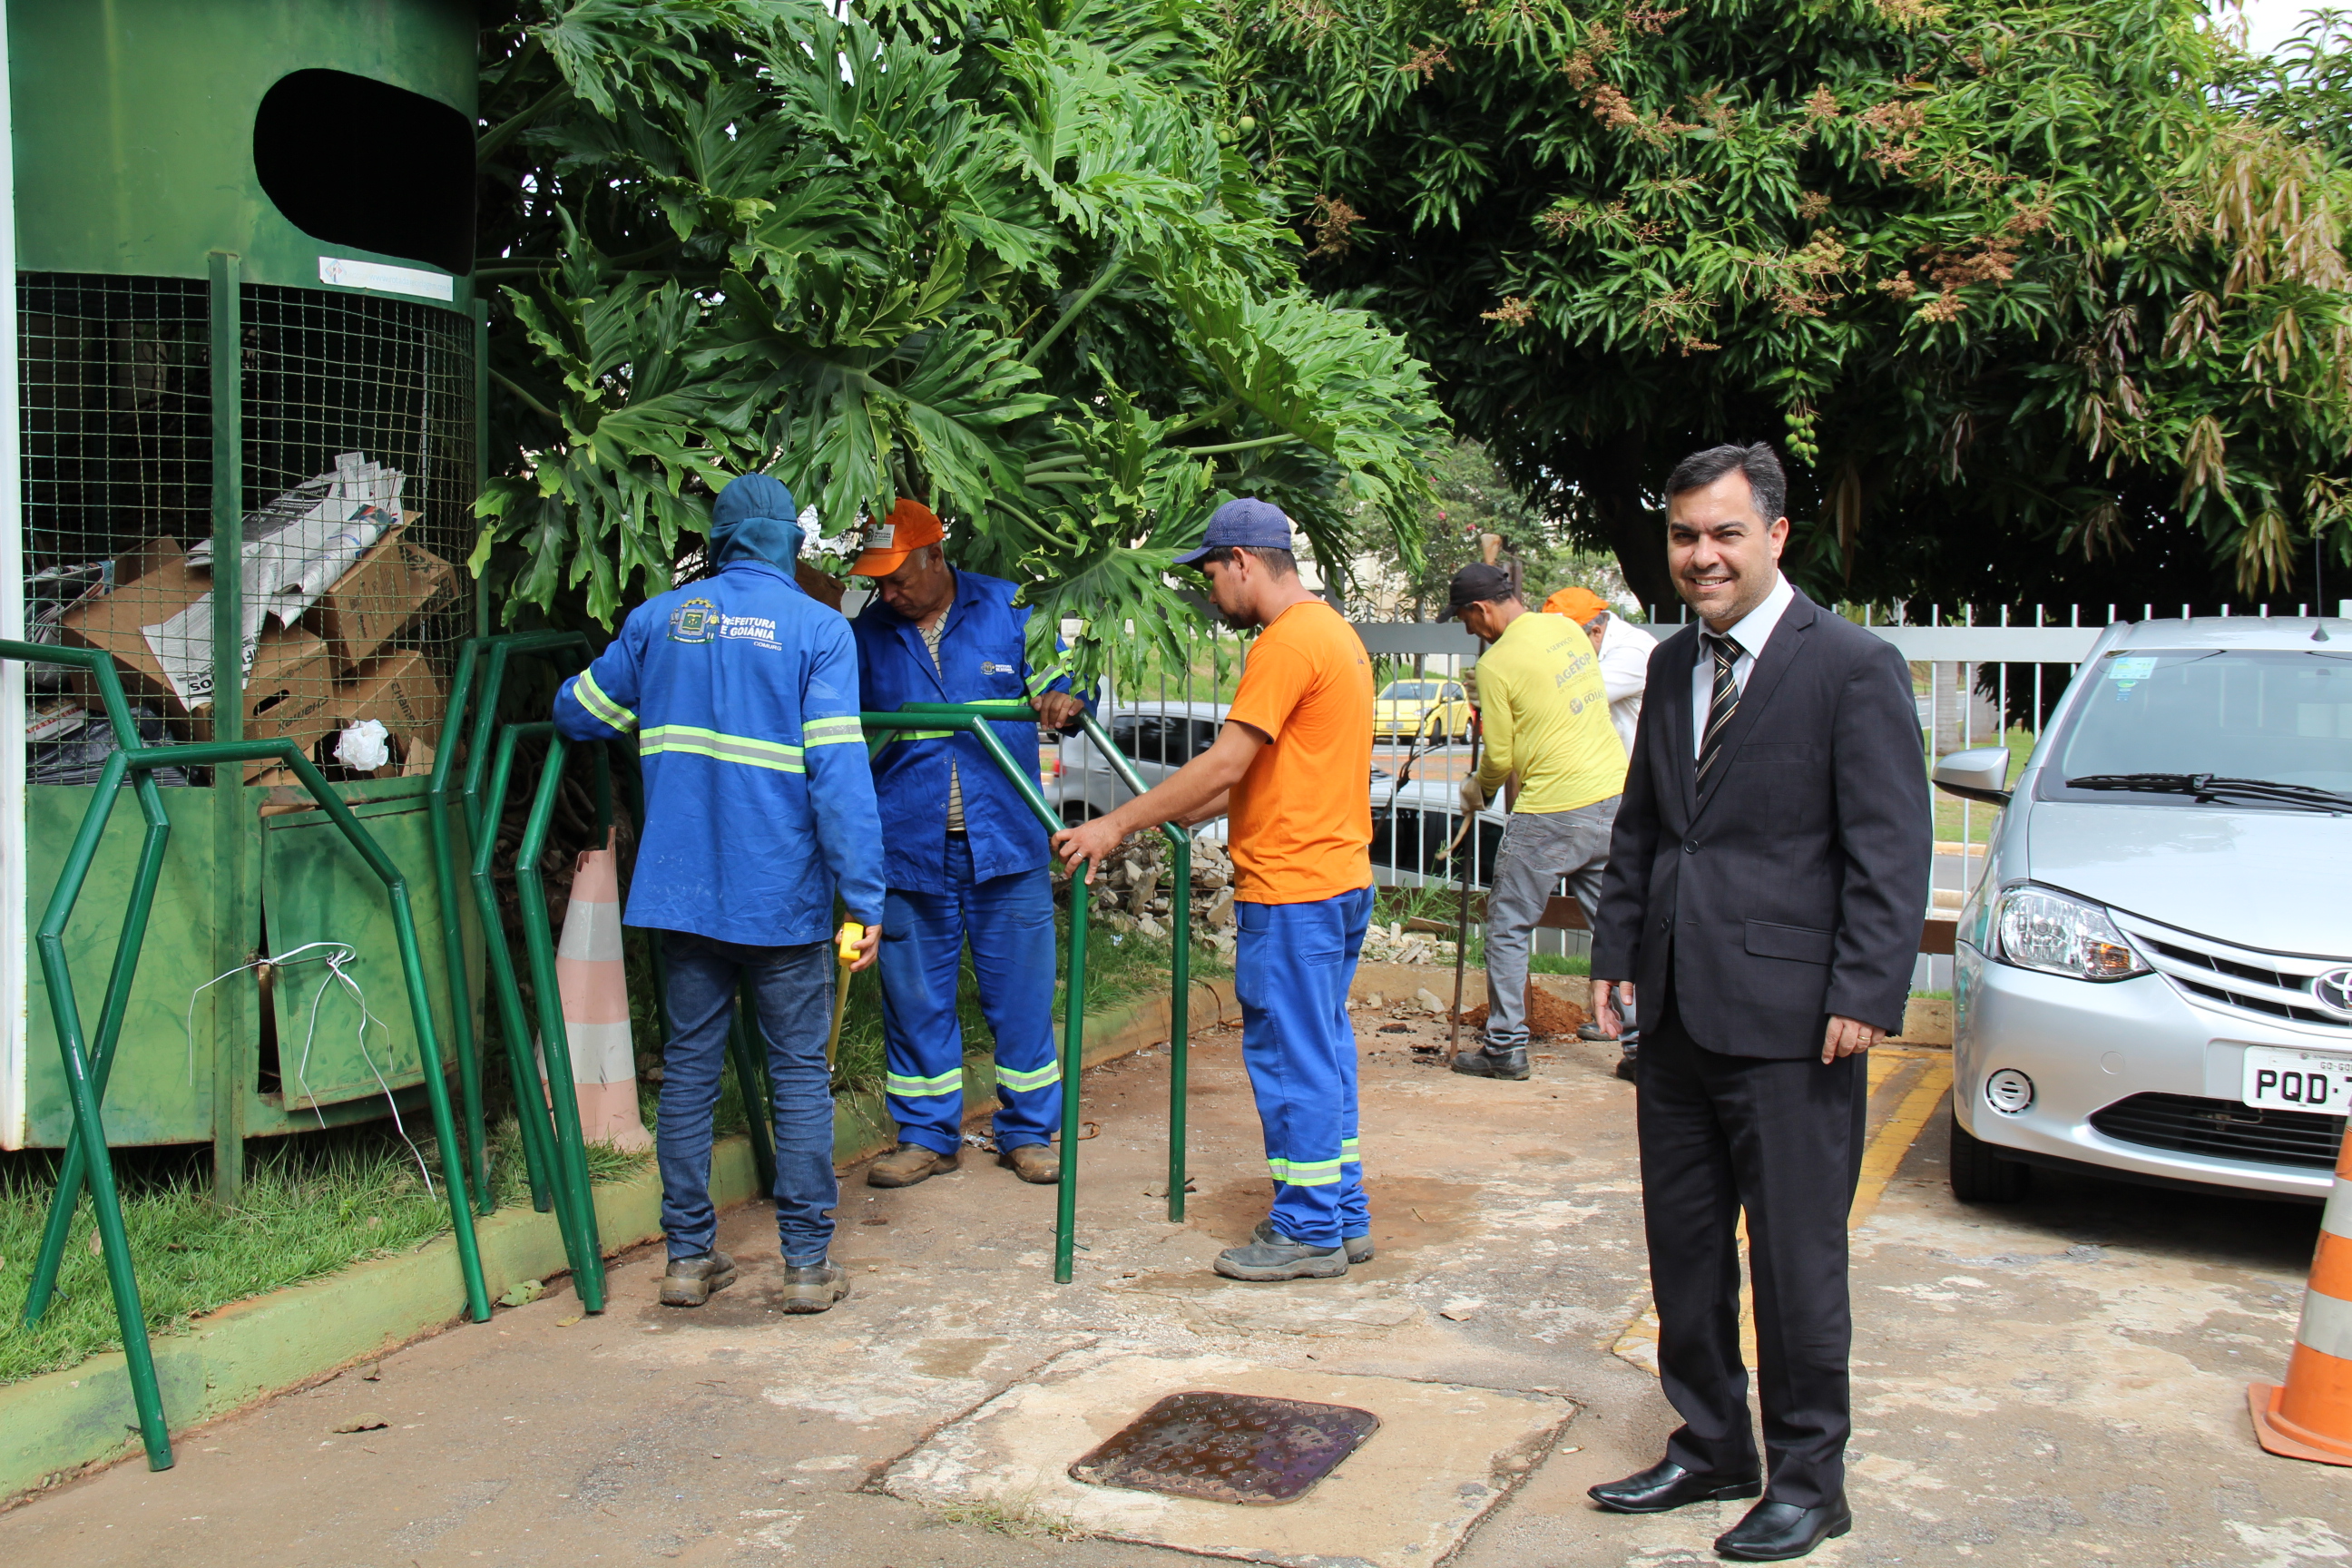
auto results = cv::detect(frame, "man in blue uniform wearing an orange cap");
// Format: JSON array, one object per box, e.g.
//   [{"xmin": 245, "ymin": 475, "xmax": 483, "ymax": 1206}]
[{"xmin": 849, "ymin": 501, "xmax": 1084, "ymax": 1187}]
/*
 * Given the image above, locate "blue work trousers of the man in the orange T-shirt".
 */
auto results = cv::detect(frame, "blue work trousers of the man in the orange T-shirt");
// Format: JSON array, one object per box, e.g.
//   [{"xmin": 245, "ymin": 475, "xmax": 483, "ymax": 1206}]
[{"xmin": 1232, "ymin": 888, "xmax": 1371, "ymax": 1246}]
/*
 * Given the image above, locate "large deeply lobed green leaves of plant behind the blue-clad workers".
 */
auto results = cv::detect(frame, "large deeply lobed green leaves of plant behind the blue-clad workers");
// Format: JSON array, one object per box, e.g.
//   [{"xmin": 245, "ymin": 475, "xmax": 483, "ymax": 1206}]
[{"xmin": 475, "ymin": 0, "xmax": 1446, "ymax": 663}]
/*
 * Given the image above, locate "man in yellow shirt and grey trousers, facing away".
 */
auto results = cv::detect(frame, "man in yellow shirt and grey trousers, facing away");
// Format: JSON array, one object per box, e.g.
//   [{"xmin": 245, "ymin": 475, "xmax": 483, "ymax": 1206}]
[{"xmin": 1439, "ymin": 564, "xmax": 1625, "ymax": 1079}]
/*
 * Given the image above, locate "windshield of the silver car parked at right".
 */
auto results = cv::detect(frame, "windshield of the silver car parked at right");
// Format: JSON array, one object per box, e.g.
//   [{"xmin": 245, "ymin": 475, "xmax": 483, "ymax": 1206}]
[{"xmin": 2051, "ymin": 649, "xmax": 2352, "ymax": 807}]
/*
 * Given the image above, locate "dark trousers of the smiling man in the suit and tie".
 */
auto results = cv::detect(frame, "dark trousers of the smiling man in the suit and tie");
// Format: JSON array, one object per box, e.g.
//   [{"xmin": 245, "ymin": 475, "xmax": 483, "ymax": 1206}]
[{"xmin": 1640, "ymin": 1006, "xmax": 1870, "ymax": 1507}]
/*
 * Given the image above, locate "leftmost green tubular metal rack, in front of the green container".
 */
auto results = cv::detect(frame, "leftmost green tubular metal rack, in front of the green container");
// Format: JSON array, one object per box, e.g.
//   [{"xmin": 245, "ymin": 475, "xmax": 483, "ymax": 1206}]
[{"xmin": 0, "ymin": 642, "xmax": 489, "ymax": 1469}]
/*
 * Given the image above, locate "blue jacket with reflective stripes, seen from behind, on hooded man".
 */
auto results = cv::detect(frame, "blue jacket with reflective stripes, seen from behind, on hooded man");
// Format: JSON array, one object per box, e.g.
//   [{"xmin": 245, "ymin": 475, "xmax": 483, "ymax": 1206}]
[{"xmin": 555, "ymin": 560, "xmax": 882, "ymax": 947}]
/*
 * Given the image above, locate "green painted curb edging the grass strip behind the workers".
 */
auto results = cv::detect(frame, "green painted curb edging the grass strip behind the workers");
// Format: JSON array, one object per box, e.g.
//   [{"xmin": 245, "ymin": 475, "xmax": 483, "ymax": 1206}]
[{"xmin": 0, "ymin": 980, "xmax": 1240, "ymax": 1504}]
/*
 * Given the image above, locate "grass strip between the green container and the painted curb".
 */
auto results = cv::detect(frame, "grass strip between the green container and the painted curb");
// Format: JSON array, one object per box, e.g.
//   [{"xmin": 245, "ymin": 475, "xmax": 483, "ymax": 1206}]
[{"xmin": 0, "ymin": 1112, "xmax": 652, "ymax": 1382}]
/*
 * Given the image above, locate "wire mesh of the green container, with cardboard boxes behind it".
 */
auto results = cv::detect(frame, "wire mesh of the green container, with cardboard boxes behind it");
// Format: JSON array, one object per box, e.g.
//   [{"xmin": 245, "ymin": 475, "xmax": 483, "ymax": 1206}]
[{"xmin": 19, "ymin": 273, "xmax": 475, "ymax": 783}]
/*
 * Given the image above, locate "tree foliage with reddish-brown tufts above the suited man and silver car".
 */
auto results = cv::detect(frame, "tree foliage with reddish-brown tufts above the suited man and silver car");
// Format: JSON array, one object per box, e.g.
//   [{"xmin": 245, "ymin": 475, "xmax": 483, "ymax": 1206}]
[{"xmin": 1219, "ymin": 0, "xmax": 2352, "ymax": 606}]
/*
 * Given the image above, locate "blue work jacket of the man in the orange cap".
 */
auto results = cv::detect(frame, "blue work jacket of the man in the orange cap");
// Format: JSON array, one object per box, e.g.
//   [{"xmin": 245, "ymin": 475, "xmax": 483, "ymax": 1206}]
[{"xmin": 851, "ymin": 572, "xmax": 1070, "ymax": 893}]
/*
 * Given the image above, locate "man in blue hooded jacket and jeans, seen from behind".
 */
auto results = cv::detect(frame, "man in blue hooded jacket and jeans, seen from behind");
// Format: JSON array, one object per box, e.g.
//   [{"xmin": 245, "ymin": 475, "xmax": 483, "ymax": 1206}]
[{"xmin": 555, "ymin": 475, "xmax": 882, "ymax": 1312}]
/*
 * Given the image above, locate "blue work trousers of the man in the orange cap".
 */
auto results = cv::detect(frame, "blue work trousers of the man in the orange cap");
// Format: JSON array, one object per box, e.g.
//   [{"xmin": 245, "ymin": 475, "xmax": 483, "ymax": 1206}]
[{"xmin": 882, "ymin": 832, "xmax": 1061, "ymax": 1154}]
